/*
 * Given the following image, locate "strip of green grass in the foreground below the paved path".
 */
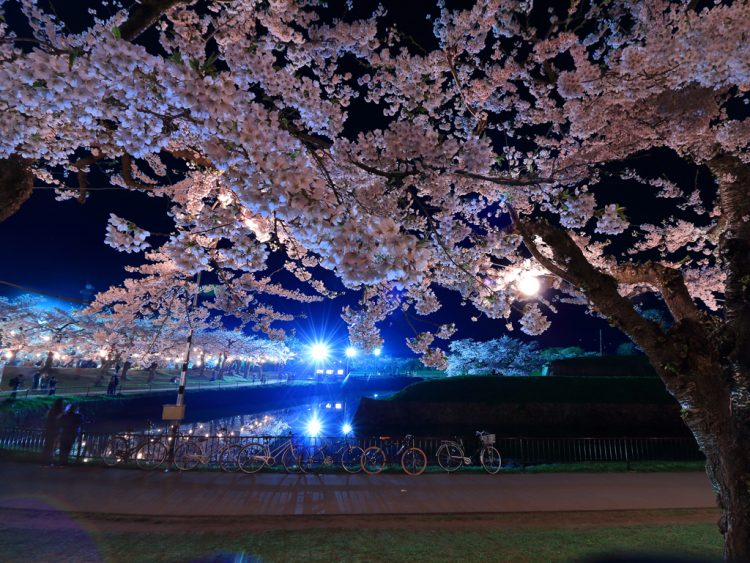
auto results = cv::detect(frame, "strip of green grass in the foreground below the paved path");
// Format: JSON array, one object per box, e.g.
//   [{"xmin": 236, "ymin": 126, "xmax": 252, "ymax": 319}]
[{"xmin": 0, "ymin": 524, "xmax": 721, "ymax": 563}]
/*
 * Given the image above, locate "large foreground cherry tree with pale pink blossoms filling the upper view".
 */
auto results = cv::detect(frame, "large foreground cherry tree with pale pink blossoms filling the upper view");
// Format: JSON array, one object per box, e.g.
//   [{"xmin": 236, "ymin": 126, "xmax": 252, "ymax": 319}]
[{"xmin": 0, "ymin": 0, "xmax": 750, "ymax": 558}]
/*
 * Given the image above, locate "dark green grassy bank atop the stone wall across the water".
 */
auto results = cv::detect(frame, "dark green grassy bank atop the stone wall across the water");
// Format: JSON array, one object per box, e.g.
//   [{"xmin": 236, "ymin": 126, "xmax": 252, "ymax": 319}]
[{"xmin": 388, "ymin": 376, "xmax": 674, "ymax": 404}]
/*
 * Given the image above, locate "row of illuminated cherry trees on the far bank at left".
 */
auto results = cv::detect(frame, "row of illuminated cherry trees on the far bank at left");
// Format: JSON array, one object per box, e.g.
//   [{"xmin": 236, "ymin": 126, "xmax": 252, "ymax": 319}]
[{"xmin": 0, "ymin": 296, "xmax": 290, "ymax": 376}]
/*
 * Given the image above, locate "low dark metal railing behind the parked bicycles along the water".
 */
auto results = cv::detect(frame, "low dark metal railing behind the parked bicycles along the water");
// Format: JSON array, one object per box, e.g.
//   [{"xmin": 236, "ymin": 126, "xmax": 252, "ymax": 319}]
[{"xmin": 0, "ymin": 428, "xmax": 704, "ymax": 467}]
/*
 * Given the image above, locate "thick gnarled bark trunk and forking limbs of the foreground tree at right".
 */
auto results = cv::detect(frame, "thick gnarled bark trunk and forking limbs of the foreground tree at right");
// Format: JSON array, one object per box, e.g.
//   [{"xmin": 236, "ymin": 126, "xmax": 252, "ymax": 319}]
[{"xmin": 513, "ymin": 156, "xmax": 750, "ymax": 561}]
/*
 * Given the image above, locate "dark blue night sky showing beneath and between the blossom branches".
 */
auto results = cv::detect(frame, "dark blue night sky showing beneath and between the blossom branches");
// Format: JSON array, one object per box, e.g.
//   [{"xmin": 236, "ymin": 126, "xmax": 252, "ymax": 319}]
[{"xmin": 0, "ymin": 2, "xmax": 627, "ymax": 355}]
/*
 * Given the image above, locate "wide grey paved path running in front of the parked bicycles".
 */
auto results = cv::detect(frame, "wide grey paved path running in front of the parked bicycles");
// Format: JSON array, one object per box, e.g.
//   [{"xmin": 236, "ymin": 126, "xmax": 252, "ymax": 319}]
[{"xmin": 0, "ymin": 463, "xmax": 716, "ymax": 516}]
